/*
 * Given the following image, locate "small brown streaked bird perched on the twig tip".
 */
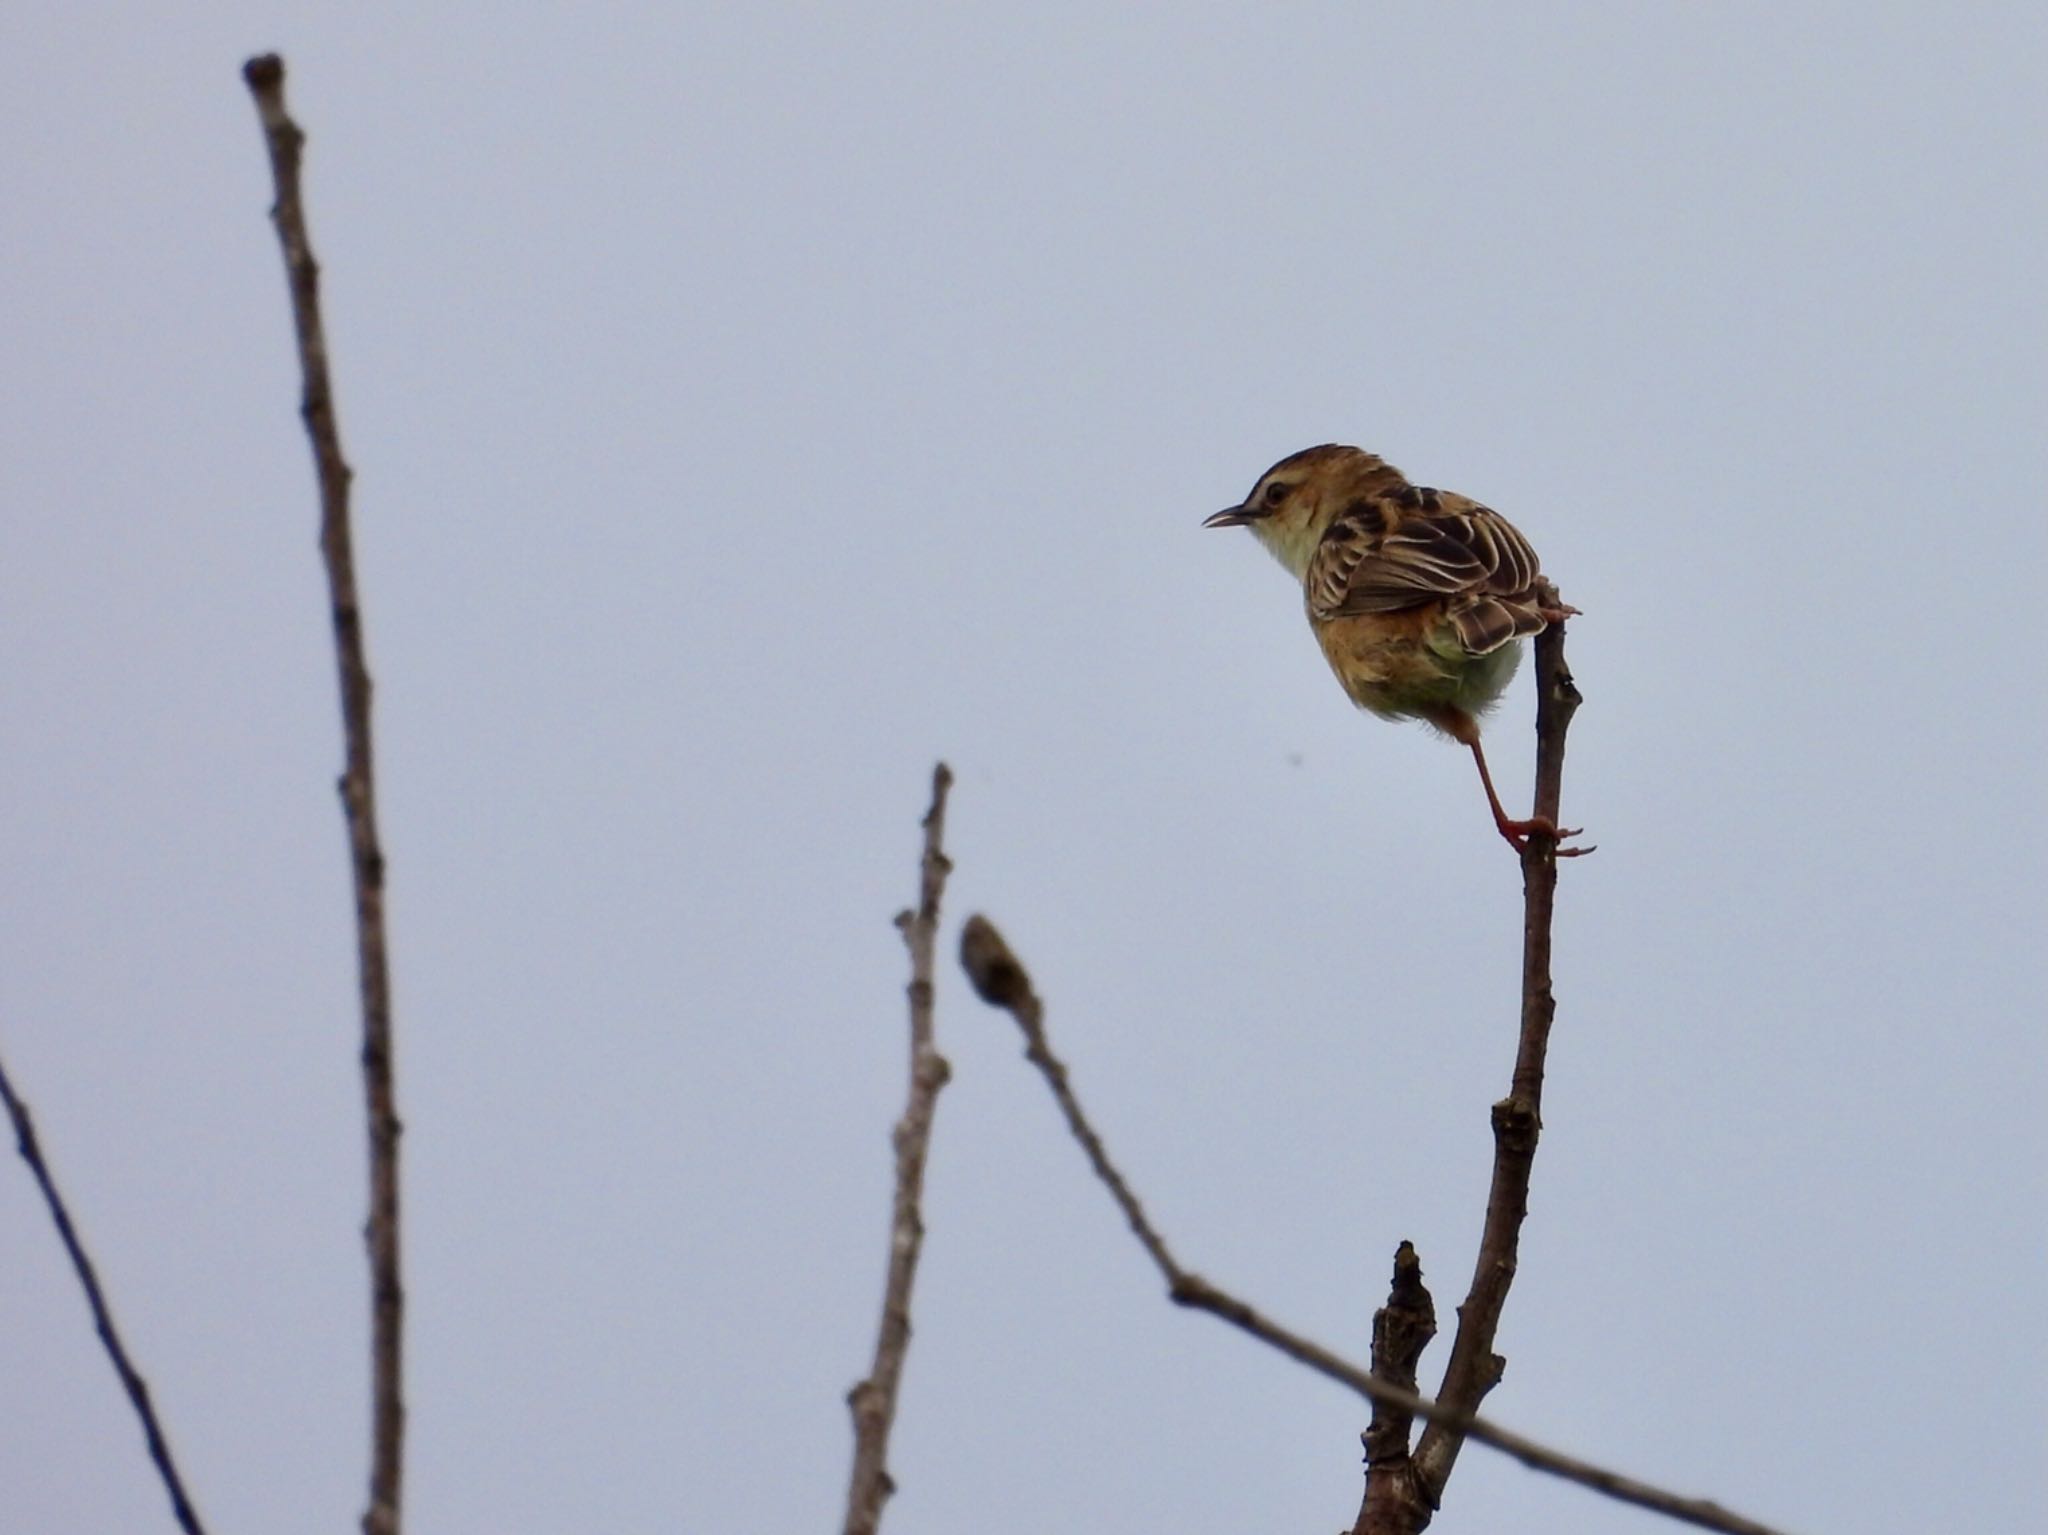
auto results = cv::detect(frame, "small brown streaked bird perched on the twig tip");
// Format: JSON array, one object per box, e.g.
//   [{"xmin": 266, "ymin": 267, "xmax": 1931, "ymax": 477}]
[{"xmin": 1202, "ymin": 442, "xmax": 1593, "ymax": 858}]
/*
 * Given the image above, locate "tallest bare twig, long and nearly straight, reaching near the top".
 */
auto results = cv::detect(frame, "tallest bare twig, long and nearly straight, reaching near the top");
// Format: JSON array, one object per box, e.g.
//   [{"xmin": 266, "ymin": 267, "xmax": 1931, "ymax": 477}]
[{"xmin": 242, "ymin": 53, "xmax": 406, "ymax": 1535}]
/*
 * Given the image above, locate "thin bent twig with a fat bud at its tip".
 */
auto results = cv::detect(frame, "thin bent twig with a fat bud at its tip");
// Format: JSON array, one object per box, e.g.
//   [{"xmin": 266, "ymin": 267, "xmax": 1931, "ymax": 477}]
[{"xmin": 961, "ymin": 917, "xmax": 1782, "ymax": 1535}]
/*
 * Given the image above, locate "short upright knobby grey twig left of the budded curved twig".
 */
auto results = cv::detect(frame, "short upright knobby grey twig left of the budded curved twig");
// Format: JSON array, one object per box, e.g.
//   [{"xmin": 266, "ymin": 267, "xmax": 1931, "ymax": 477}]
[{"xmin": 846, "ymin": 763, "xmax": 952, "ymax": 1535}]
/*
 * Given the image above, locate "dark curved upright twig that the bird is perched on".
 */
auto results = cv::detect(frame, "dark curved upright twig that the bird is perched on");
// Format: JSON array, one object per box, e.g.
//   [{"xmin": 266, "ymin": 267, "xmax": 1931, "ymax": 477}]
[{"xmin": 1409, "ymin": 591, "xmax": 1579, "ymax": 1531}]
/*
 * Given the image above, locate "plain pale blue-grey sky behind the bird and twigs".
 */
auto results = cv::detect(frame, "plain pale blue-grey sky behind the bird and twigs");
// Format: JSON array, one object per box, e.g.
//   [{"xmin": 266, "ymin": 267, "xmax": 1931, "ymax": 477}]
[{"xmin": 0, "ymin": 4, "xmax": 2048, "ymax": 1535}]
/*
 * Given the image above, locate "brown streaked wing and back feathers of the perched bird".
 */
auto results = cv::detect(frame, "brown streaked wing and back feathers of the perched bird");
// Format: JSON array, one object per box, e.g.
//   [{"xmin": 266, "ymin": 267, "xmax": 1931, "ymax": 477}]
[{"xmin": 1305, "ymin": 485, "xmax": 1538, "ymax": 622}]
